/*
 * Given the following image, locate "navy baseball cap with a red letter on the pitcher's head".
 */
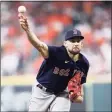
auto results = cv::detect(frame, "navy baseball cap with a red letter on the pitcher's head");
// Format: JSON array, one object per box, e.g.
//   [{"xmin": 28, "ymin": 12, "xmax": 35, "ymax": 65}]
[{"xmin": 65, "ymin": 29, "xmax": 84, "ymax": 40}]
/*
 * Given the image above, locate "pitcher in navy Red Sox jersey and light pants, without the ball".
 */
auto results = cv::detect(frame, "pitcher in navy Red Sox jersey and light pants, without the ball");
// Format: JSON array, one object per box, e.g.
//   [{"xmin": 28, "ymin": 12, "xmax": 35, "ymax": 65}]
[{"xmin": 18, "ymin": 14, "xmax": 89, "ymax": 111}]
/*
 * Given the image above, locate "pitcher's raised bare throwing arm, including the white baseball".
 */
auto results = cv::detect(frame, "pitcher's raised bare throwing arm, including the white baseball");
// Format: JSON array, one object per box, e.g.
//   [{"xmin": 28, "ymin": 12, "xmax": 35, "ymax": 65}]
[{"xmin": 18, "ymin": 6, "xmax": 48, "ymax": 58}]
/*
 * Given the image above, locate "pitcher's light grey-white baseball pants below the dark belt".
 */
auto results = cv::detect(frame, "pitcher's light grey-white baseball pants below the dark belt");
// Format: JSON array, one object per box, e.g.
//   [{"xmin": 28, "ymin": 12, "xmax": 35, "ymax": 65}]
[{"xmin": 29, "ymin": 83, "xmax": 71, "ymax": 112}]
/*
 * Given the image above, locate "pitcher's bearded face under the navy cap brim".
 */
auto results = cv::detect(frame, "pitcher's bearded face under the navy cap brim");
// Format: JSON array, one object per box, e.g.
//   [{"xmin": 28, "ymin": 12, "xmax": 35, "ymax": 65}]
[{"xmin": 65, "ymin": 38, "xmax": 83, "ymax": 54}]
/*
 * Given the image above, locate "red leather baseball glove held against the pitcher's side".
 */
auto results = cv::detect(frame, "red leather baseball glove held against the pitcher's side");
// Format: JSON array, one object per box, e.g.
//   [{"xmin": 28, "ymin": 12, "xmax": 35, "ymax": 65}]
[{"xmin": 68, "ymin": 72, "xmax": 81, "ymax": 101}]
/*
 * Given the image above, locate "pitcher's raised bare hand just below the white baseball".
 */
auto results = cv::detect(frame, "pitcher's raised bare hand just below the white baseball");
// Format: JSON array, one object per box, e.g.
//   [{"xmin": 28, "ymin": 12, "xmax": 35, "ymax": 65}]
[{"xmin": 18, "ymin": 13, "xmax": 29, "ymax": 31}]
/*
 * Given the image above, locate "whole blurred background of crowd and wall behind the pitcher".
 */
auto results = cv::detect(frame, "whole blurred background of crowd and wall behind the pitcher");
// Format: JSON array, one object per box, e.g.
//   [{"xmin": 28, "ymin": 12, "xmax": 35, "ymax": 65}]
[{"xmin": 1, "ymin": 1, "xmax": 112, "ymax": 111}]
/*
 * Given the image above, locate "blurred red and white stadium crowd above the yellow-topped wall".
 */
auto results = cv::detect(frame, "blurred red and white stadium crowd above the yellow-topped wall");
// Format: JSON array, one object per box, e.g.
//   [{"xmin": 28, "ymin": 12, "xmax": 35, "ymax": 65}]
[{"xmin": 1, "ymin": 1, "xmax": 111, "ymax": 76}]
